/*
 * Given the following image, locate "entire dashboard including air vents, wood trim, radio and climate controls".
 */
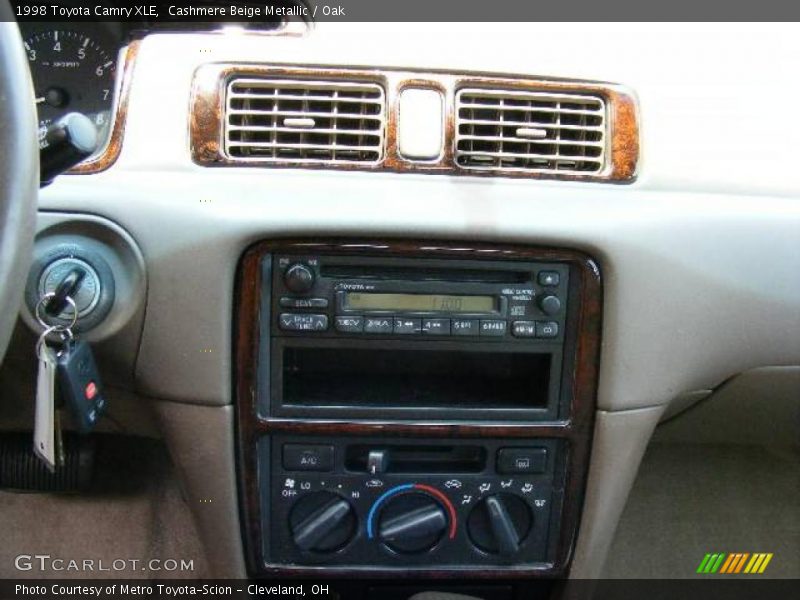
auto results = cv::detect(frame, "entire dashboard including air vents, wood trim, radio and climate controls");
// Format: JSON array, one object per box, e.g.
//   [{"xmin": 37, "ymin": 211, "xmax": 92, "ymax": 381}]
[{"xmin": 1, "ymin": 14, "xmax": 800, "ymax": 596}]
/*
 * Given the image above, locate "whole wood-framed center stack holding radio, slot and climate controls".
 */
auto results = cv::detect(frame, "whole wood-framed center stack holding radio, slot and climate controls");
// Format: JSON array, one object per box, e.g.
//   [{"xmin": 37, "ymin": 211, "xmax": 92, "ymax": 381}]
[{"xmin": 236, "ymin": 240, "xmax": 601, "ymax": 577}]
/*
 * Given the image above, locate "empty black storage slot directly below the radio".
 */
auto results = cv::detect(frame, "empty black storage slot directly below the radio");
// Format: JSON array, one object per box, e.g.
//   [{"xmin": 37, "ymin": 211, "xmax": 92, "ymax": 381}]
[{"xmin": 275, "ymin": 343, "xmax": 553, "ymax": 410}]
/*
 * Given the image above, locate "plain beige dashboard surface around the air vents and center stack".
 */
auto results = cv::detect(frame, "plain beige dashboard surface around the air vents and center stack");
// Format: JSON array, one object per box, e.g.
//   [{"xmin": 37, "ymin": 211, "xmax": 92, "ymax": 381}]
[{"xmin": 12, "ymin": 23, "xmax": 800, "ymax": 578}]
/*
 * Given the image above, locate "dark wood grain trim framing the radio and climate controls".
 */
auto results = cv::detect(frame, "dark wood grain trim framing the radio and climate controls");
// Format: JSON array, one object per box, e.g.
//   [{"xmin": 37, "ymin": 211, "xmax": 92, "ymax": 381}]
[{"xmin": 233, "ymin": 240, "xmax": 602, "ymax": 578}]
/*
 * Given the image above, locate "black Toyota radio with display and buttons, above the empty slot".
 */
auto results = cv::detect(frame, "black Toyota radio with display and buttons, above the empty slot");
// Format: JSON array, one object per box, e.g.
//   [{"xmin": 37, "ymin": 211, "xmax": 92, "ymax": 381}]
[{"xmin": 272, "ymin": 255, "xmax": 569, "ymax": 342}]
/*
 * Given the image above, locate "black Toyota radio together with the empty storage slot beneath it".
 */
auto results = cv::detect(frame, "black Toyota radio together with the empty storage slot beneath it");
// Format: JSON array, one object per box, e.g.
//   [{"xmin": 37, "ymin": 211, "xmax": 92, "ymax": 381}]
[{"xmin": 262, "ymin": 254, "xmax": 570, "ymax": 420}]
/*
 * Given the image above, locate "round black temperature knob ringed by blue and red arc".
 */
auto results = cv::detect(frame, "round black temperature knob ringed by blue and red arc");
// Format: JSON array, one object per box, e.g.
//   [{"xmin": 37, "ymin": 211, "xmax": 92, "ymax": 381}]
[{"xmin": 378, "ymin": 493, "xmax": 447, "ymax": 554}]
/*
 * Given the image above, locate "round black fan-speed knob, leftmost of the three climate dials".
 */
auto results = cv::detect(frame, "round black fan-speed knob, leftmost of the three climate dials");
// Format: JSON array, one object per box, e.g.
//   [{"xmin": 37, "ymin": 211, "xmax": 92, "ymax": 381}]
[{"xmin": 289, "ymin": 492, "xmax": 356, "ymax": 553}]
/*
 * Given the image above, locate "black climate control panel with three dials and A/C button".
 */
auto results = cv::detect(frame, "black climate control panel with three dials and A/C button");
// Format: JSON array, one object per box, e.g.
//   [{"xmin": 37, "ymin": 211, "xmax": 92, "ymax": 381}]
[{"xmin": 259, "ymin": 436, "xmax": 566, "ymax": 570}]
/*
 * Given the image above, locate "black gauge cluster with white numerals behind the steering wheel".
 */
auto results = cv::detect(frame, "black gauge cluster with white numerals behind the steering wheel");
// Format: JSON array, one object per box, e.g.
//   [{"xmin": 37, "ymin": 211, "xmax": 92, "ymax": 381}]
[{"xmin": 22, "ymin": 23, "xmax": 127, "ymax": 156}]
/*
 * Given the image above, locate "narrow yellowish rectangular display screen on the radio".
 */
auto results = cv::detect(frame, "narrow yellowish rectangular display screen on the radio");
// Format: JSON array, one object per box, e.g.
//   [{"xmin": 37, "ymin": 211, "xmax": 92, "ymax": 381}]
[{"xmin": 344, "ymin": 292, "xmax": 497, "ymax": 313}]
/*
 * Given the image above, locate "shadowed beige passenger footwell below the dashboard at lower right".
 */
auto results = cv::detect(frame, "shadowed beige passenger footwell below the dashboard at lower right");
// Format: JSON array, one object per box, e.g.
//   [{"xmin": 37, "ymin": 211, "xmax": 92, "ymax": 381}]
[{"xmin": 603, "ymin": 368, "xmax": 800, "ymax": 579}]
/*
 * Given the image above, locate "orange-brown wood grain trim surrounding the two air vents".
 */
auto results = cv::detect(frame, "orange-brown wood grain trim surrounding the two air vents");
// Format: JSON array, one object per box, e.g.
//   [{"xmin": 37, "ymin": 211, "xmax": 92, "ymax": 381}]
[{"xmin": 189, "ymin": 63, "xmax": 639, "ymax": 183}]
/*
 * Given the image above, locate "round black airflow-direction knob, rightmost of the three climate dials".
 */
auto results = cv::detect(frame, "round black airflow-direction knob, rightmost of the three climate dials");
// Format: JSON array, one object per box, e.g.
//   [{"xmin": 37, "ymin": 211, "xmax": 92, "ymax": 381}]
[{"xmin": 467, "ymin": 494, "xmax": 533, "ymax": 557}]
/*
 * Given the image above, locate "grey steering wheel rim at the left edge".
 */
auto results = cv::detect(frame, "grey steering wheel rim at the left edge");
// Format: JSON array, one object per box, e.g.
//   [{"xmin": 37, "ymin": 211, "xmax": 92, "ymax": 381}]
[{"xmin": 0, "ymin": 7, "xmax": 39, "ymax": 361}]
